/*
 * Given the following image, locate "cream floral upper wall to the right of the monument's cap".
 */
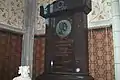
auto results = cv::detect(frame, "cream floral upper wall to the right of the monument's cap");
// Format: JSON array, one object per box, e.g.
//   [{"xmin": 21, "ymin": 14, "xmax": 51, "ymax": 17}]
[{"xmin": 88, "ymin": 0, "xmax": 112, "ymax": 22}]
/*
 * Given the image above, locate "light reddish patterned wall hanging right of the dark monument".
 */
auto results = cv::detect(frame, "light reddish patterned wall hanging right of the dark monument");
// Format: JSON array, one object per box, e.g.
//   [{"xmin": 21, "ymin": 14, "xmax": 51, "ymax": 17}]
[{"xmin": 88, "ymin": 27, "xmax": 114, "ymax": 80}]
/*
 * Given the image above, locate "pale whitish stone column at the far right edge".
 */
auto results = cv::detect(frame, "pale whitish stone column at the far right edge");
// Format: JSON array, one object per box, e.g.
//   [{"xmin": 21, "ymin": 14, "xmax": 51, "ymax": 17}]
[{"xmin": 112, "ymin": 0, "xmax": 120, "ymax": 80}]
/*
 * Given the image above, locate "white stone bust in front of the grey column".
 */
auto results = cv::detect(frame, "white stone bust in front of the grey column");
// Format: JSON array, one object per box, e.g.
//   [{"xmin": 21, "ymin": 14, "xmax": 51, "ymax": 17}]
[{"xmin": 13, "ymin": 66, "xmax": 31, "ymax": 80}]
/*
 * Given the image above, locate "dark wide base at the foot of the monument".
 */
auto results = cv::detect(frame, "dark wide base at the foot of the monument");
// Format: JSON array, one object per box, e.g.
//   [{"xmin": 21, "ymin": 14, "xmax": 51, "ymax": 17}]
[{"xmin": 36, "ymin": 73, "xmax": 94, "ymax": 80}]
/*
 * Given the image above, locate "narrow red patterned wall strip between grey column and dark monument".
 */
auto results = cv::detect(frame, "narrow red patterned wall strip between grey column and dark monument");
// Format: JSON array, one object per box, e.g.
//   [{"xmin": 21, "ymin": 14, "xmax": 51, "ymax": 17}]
[{"xmin": 33, "ymin": 36, "xmax": 45, "ymax": 77}]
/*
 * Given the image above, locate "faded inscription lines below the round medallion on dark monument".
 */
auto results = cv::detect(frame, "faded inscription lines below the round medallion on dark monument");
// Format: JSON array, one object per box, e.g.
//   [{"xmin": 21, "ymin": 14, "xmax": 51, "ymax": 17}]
[{"xmin": 53, "ymin": 39, "xmax": 74, "ymax": 72}]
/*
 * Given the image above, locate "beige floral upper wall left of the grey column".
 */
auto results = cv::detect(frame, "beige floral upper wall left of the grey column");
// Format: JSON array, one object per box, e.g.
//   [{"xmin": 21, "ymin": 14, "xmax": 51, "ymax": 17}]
[{"xmin": 0, "ymin": 0, "xmax": 24, "ymax": 28}]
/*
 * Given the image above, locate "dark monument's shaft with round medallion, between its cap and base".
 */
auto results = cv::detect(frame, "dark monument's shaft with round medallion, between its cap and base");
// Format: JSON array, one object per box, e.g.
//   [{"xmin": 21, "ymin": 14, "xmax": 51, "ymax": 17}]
[{"xmin": 45, "ymin": 13, "xmax": 88, "ymax": 74}]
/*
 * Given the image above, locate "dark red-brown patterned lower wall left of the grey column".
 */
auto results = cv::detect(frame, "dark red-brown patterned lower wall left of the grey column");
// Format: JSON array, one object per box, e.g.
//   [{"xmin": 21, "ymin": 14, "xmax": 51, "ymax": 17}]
[{"xmin": 0, "ymin": 31, "xmax": 22, "ymax": 80}]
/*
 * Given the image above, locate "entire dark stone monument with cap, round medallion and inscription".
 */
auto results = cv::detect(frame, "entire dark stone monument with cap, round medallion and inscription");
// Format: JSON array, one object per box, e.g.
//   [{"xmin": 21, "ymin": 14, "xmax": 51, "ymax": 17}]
[{"xmin": 36, "ymin": 0, "xmax": 93, "ymax": 80}]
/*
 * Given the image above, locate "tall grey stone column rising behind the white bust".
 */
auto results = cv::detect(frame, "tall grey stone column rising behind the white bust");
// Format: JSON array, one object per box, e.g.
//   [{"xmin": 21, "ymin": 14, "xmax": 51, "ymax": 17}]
[{"xmin": 21, "ymin": 0, "xmax": 36, "ymax": 77}]
